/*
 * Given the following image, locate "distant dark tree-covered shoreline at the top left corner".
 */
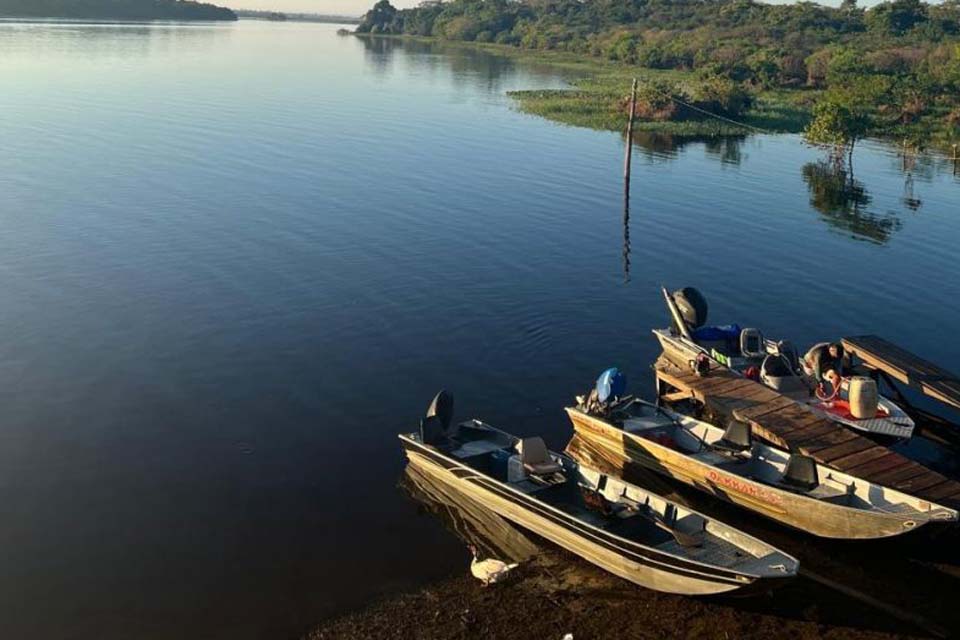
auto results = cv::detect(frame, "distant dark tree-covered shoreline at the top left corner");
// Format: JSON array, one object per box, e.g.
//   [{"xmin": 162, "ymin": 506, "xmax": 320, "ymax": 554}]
[{"xmin": 0, "ymin": 0, "xmax": 237, "ymax": 20}]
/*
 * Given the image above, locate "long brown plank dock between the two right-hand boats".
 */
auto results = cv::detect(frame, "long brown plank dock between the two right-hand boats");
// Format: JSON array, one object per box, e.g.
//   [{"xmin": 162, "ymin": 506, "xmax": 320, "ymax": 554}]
[{"xmin": 654, "ymin": 357, "xmax": 960, "ymax": 509}]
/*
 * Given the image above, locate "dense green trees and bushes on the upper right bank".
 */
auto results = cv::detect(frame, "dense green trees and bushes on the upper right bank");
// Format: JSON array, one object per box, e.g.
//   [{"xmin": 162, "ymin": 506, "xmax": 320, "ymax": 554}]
[{"xmin": 358, "ymin": 0, "xmax": 960, "ymax": 146}]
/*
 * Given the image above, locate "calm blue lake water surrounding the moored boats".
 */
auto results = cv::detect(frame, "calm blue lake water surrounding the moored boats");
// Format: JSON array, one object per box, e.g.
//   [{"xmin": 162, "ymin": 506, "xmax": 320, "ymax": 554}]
[{"xmin": 0, "ymin": 21, "xmax": 960, "ymax": 639}]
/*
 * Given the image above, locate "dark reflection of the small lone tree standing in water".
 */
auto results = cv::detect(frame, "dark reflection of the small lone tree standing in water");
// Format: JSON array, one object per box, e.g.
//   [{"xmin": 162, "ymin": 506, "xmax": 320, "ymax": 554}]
[{"xmin": 801, "ymin": 158, "xmax": 901, "ymax": 244}]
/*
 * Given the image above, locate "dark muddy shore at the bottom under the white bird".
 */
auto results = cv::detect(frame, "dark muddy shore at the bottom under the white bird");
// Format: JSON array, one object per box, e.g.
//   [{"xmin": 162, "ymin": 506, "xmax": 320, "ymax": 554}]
[{"xmin": 305, "ymin": 550, "xmax": 930, "ymax": 640}]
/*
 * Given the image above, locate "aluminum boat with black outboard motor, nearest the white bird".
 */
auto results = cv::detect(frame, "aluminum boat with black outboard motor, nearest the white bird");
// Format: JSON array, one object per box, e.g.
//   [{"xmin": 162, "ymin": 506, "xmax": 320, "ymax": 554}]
[{"xmin": 400, "ymin": 392, "xmax": 798, "ymax": 595}]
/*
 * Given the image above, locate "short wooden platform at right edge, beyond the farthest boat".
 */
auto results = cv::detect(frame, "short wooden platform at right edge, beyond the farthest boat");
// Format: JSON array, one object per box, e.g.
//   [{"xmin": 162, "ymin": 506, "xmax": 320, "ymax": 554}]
[{"xmin": 843, "ymin": 336, "xmax": 960, "ymax": 409}]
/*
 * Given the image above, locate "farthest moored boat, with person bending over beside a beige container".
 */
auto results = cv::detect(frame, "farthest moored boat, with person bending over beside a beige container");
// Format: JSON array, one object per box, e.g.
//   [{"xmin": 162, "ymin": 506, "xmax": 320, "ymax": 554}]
[{"xmin": 653, "ymin": 287, "xmax": 915, "ymax": 439}]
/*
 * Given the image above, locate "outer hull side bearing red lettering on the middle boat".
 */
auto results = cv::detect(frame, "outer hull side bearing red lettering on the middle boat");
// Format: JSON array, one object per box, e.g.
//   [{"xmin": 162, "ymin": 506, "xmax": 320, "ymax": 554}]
[{"xmin": 567, "ymin": 408, "xmax": 926, "ymax": 539}]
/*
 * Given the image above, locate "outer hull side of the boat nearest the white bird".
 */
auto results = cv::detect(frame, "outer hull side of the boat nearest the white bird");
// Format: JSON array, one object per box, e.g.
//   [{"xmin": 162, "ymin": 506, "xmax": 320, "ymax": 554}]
[{"xmin": 401, "ymin": 436, "xmax": 766, "ymax": 595}]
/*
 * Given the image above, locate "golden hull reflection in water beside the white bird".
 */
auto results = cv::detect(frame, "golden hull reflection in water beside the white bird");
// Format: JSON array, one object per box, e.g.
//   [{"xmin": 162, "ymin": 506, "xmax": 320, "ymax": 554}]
[{"xmin": 400, "ymin": 460, "xmax": 538, "ymax": 562}]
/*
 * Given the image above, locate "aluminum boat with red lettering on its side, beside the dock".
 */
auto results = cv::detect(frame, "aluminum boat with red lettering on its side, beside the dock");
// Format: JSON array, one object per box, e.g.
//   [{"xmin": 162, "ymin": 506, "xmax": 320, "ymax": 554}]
[{"xmin": 567, "ymin": 397, "xmax": 958, "ymax": 539}]
